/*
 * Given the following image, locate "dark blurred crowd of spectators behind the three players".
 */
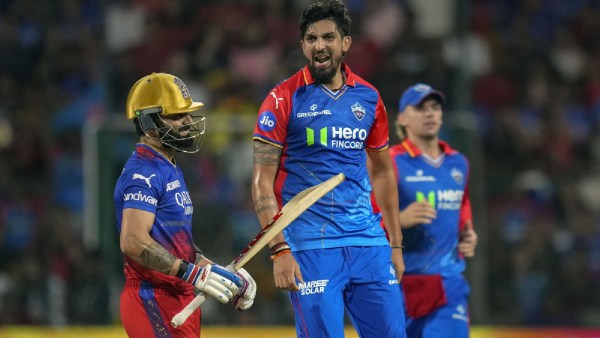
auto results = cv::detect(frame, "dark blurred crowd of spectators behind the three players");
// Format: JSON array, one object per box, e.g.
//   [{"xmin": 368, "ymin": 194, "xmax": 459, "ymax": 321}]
[{"xmin": 0, "ymin": 0, "xmax": 600, "ymax": 326}]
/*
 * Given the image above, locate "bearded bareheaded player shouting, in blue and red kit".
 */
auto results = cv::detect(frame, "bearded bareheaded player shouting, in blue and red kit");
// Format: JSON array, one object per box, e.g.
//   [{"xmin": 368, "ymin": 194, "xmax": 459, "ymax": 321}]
[{"xmin": 252, "ymin": 1, "xmax": 405, "ymax": 338}]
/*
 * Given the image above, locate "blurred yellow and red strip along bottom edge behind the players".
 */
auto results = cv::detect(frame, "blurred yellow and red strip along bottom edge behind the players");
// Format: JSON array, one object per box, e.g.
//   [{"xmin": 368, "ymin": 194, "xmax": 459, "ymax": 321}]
[{"xmin": 0, "ymin": 326, "xmax": 600, "ymax": 338}]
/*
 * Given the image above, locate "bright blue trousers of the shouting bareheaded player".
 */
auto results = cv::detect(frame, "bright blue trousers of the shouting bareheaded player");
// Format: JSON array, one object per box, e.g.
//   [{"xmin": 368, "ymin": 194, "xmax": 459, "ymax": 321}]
[{"xmin": 290, "ymin": 246, "xmax": 406, "ymax": 338}]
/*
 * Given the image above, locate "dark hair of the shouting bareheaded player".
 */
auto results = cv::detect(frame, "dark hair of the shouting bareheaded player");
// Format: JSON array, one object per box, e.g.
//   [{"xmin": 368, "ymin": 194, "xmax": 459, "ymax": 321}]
[{"xmin": 300, "ymin": 0, "xmax": 352, "ymax": 39}]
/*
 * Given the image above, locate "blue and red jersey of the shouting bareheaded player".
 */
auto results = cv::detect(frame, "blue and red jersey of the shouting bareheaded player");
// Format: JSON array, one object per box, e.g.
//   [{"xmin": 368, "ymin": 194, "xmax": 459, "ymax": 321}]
[{"xmin": 253, "ymin": 64, "xmax": 388, "ymax": 251}]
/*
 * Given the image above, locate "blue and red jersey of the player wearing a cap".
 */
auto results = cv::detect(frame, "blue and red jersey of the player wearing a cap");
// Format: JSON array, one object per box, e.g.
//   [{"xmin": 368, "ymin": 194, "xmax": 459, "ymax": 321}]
[{"xmin": 390, "ymin": 139, "xmax": 471, "ymax": 277}]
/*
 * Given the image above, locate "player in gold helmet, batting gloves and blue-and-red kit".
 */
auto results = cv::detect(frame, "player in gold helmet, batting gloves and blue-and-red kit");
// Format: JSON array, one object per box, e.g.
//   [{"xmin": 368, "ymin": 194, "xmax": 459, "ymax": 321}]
[{"xmin": 114, "ymin": 73, "xmax": 256, "ymax": 338}]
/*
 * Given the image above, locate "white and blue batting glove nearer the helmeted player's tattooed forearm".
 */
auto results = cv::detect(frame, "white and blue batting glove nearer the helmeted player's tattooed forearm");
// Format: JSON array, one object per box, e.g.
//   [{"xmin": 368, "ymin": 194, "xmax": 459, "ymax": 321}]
[{"xmin": 181, "ymin": 262, "xmax": 243, "ymax": 303}]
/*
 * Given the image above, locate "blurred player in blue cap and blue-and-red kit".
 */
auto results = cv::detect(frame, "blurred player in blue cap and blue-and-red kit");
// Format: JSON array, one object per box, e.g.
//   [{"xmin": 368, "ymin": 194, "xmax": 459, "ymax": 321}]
[{"xmin": 390, "ymin": 83, "xmax": 477, "ymax": 338}]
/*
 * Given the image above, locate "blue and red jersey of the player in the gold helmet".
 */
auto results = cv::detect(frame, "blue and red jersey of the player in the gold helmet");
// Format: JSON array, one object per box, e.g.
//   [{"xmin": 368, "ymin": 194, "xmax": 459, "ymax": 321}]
[{"xmin": 114, "ymin": 144, "xmax": 196, "ymax": 294}]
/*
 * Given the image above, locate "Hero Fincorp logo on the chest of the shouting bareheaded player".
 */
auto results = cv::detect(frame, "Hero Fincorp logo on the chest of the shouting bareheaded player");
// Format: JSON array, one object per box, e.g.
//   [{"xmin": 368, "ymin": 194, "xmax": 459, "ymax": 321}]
[{"xmin": 306, "ymin": 127, "xmax": 368, "ymax": 149}]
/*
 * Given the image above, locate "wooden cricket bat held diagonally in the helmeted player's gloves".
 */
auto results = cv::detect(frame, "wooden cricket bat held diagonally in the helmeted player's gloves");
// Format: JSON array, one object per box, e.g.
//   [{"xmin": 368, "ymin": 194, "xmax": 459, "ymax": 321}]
[{"xmin": 171, "ymin": 173, "xmax": 346, "ymax": 327}]
